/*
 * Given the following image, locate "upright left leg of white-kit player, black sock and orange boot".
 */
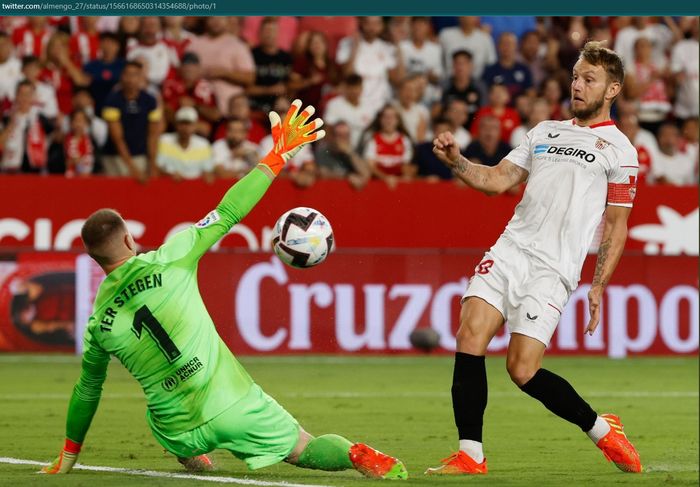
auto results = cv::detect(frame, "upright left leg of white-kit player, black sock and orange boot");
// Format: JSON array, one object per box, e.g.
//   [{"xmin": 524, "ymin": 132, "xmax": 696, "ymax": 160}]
[{"xmin": 425, "ymin": 294, "xmax": 505, "ymax": 475}]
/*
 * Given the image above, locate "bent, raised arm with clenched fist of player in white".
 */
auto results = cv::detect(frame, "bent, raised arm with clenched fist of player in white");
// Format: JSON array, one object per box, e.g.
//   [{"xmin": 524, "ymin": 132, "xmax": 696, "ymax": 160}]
[{"xmin": 433, "ymin": 132, "xmax": 529, "ymax": 195}]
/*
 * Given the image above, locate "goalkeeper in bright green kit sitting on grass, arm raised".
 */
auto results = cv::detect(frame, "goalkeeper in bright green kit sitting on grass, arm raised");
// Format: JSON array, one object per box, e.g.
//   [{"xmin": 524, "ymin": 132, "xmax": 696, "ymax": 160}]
[{"xmin": 42, "ymin": 100, "xmax": 408, "ymax": 479}]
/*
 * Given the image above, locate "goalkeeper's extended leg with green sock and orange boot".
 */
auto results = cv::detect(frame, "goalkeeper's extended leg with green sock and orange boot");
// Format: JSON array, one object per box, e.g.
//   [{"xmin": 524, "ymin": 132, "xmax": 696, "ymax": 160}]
[{"xmin": 285, "ymin": 427, "xmax": 408, "ymax": 479}]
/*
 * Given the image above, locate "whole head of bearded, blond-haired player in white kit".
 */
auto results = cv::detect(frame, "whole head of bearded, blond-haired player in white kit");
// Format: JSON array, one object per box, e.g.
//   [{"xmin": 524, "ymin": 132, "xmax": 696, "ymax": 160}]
[{"xmin": 571, "ymin": 41, "xmax": 625, "ymax": 121}]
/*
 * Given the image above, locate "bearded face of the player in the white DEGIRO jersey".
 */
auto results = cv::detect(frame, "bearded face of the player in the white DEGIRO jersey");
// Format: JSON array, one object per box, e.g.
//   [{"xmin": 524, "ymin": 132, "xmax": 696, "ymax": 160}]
[{"xmin": 571, "ymin": 59, "xmax": 608, "ymax": 120}]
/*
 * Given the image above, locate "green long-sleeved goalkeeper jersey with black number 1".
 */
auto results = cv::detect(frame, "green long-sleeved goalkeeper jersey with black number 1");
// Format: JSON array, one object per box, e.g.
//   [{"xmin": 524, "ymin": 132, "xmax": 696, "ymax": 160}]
[{"xmin": 67, "ymin": 169, "xmax": 270, "ymax": 443}]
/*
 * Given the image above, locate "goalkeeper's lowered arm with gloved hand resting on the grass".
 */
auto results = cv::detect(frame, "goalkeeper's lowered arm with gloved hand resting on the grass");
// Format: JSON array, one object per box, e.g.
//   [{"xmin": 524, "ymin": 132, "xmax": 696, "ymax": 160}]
[{"xmin": 41, "ymin": 330, "xmax": 109, "ymax": 474}]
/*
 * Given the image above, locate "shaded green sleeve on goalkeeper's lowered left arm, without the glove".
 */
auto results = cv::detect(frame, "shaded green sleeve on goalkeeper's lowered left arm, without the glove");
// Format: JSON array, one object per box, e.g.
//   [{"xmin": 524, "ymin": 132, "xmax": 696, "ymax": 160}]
[{"xmin": 66, "ymin": 326, "xmax": 109, "ymax": 443}]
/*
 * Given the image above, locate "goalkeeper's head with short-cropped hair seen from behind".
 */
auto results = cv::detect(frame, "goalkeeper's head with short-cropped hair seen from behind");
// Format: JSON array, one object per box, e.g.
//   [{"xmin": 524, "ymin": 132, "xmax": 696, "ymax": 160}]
[{"xmin": 80, "ymin": 208, "xmax": 136, "ymax": 273}]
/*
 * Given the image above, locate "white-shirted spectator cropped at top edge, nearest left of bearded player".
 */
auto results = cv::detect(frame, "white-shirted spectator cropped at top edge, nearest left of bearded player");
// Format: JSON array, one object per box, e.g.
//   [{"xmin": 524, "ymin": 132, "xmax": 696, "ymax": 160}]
[{"xmin": 440, "ymin": 17, "xmax": 496, "ymax": 79}]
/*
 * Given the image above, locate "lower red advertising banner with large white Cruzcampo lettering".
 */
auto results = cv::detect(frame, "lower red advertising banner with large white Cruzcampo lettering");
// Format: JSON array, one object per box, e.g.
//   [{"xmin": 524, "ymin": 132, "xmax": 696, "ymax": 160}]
[{"xmin": 0, "ymin": 251, "xmax": 700, "ymax": 357}]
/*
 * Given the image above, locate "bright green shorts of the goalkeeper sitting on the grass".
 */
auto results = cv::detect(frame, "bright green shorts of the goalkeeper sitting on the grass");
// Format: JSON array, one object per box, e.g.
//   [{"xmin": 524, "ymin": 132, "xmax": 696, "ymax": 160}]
[{"xmin": 153, "ymin": 384, "xmax": 299, "ymax": 470}]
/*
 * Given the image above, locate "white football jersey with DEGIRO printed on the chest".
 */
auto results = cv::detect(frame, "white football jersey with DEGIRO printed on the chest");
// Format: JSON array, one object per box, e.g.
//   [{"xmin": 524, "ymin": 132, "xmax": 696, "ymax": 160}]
[{"xmin": 502, "ymin": 120, "xmax": 639, "ymax": 291}]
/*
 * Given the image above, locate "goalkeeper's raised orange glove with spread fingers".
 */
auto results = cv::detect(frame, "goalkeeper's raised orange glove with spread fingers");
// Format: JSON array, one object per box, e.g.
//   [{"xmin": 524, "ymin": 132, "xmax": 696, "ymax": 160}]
[{"xmin": 260, "ymin": 100, "xmax": 326, "ymax": 176}]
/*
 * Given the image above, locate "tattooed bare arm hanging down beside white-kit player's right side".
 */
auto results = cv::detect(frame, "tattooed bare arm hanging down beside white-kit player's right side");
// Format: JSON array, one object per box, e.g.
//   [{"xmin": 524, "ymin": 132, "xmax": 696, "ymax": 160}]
[{"xmin": 584, "ymin": 205, "xmax": 632, "ymax": 335}]
